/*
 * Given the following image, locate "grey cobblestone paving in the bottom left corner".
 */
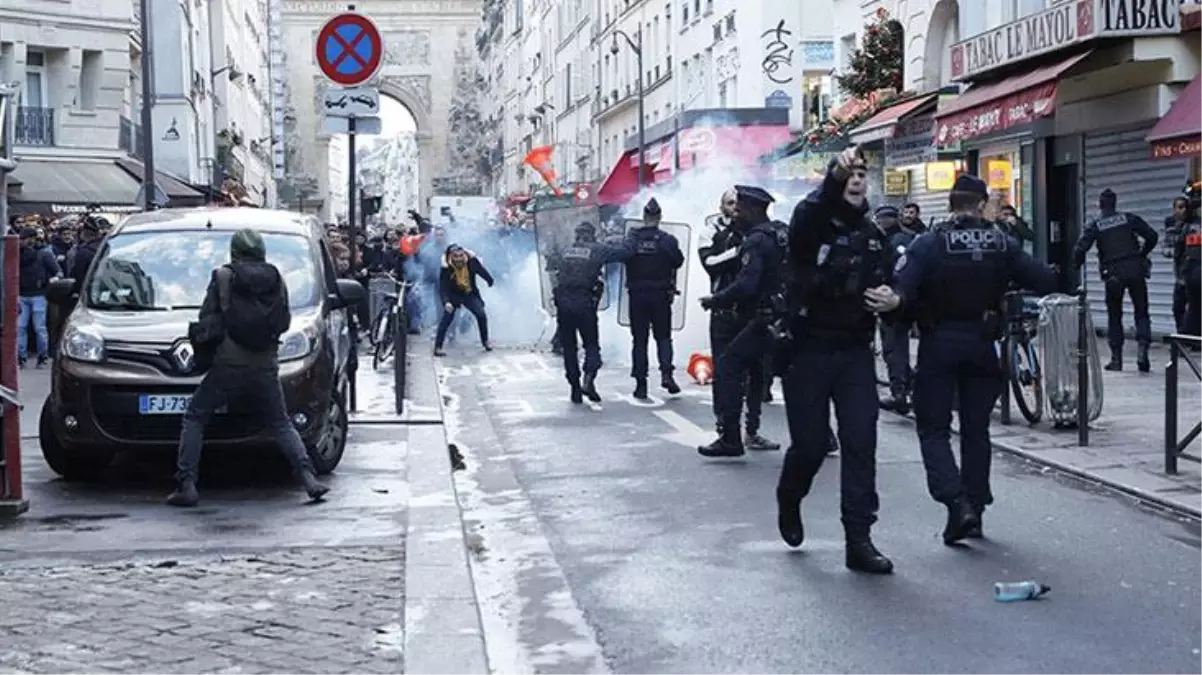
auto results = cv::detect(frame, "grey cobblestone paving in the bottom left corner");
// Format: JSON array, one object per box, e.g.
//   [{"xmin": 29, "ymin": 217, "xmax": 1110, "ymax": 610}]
[{"xmin": 0, "ymin": 548, "xmax": 404, "ymax": 674}]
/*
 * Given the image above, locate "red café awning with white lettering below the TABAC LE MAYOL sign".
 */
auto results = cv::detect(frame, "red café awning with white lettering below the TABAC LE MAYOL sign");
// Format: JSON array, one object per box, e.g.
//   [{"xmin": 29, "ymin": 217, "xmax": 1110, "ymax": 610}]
[{"xmin": 935, "ymin": 52, "xmax": 1090, "ymax": 145}]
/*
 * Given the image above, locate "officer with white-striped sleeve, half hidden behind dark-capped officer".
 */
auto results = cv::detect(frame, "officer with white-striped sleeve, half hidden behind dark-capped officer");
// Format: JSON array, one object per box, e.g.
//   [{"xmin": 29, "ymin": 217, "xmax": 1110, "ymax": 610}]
[{"xmin": 697, "ymin": 190, "xmax": 780, "ymax": 450}]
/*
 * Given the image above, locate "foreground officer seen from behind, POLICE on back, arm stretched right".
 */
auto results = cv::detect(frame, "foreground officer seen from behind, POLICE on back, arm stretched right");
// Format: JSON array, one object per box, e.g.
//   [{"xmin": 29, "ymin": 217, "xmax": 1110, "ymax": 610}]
[{"xmin": 894, "ymin": 175, "xmax": 1057, "ymax": 544}]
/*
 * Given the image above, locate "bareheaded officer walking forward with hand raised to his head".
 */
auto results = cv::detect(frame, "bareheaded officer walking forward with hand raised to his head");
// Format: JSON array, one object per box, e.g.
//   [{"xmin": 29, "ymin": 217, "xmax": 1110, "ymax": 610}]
[{"xmin": 776, "ymin": 148, "xmax": 897, "ymax": 574}]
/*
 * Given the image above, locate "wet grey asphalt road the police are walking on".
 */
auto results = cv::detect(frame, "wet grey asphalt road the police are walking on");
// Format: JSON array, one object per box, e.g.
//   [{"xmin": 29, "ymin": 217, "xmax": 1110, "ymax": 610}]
[{"xmin": 442, "ymin": 347, "xmax": 1202, "ymax": 675}]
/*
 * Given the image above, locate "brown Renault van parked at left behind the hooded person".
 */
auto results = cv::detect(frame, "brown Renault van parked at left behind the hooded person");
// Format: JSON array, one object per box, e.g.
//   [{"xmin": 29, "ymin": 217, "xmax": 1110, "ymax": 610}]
[{"xmin": 38, "ymin": 208, "xmax": 364, "ymax": 479}]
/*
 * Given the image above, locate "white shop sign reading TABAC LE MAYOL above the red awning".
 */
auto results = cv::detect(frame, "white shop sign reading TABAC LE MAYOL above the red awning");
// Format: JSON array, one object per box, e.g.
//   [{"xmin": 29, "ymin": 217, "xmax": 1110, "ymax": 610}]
[{"xmin": 951, "ymin": 0, "xmax": 1202, "ymax": 80}]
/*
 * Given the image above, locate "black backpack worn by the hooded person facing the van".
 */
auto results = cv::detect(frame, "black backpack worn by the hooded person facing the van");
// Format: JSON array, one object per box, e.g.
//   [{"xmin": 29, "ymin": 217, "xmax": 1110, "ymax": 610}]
[{"xmin": 221, "ymin": 262, "xmax": 292, "ymax": 352}]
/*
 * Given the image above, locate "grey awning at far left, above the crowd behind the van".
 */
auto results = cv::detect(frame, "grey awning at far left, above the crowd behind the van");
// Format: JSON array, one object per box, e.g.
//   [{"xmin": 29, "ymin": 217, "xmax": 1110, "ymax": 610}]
[{"xmin": 8, "ymin": 160, "xmax": 138, "ymax": 215}]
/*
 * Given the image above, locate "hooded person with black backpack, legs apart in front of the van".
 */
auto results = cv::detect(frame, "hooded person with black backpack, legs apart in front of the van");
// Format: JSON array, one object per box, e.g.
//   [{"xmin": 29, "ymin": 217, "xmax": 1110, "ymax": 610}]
[{"xmin": 167, "ymin": 228, "xmax": 329, "ymax": 507}]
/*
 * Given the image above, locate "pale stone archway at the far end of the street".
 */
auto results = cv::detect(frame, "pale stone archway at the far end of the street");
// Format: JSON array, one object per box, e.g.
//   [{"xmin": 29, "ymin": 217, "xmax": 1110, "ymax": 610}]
[{"xmin": 282, "ymin": 0, "xmax": 480, "ymax": 217}]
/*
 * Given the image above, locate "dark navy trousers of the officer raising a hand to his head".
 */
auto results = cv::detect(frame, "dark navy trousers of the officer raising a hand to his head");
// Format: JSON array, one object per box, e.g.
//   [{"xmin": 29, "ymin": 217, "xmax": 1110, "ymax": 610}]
[{"xmin": 776, "ymin": 340, "xmax": 880, "ymax": 537}]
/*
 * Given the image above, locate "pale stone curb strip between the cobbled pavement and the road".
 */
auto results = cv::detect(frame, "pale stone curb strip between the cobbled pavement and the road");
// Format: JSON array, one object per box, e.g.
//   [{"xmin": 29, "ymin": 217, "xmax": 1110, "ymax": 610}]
[{"xmin": 404, "ymin": 354, "xmax": 489, "ymax": 675}]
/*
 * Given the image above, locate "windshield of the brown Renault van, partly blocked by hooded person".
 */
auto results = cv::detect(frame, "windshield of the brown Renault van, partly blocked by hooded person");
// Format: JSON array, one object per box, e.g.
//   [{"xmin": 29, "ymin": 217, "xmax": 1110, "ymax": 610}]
[{"xmin": 85, "ymin": 229, "xmax": 320, "ymax": 311}]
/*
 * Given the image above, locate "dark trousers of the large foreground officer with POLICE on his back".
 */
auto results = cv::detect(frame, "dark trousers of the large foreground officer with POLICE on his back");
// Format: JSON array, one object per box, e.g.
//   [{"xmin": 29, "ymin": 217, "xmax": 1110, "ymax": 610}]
[{"xmin": 914, "ymin": 324, "xmax": 1005, "ymax": 509}]
